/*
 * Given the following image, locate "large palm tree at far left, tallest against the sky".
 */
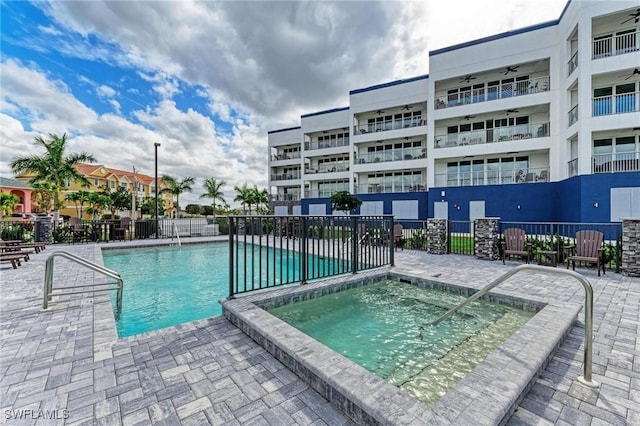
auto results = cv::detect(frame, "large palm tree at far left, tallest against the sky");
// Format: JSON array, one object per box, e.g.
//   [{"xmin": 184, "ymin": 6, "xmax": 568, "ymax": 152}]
[{"xmin": 9, "ymin": 133, "xmax": 96, "ymax": 219}]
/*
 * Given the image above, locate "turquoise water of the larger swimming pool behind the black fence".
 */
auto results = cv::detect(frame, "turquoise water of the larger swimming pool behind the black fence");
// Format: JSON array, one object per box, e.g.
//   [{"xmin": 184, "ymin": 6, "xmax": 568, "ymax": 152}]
[{"xmin": 102, "ymin": 243, "xmax": 348, "ymax": 337}]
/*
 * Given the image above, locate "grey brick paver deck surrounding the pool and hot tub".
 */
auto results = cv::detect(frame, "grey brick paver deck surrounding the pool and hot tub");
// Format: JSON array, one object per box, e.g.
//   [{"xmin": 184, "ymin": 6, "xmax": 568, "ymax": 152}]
[{"xmin": 0, "ymin": 242, "xmax": 640, "ymax": 426}]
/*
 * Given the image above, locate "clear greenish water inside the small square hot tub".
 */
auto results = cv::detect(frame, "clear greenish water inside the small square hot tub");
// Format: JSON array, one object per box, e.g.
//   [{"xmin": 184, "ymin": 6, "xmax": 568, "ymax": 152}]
[{"xmin": 269, "ymin": 281, "xmax": 535, "ymax": 404}]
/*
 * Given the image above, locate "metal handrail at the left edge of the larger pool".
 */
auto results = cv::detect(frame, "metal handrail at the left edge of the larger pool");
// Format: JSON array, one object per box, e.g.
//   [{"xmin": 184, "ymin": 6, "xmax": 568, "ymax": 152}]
[{"xmin": 42, "ymin": 251, "xmax": 123, "ymax": 319}]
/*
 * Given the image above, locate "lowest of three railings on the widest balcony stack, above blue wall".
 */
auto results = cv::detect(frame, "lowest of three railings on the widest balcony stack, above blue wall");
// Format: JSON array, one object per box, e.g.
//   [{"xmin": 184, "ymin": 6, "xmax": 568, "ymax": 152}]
[{"xmin": 435, "ymin": 167, "xmax": 549, "ymax": 186}]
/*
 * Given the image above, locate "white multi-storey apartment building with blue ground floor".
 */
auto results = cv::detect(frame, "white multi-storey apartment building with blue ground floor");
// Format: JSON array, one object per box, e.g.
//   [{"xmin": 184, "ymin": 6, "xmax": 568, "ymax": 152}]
[{"xmin": 268, "ymin": 1, "xmax": 640, "ymax": 222}]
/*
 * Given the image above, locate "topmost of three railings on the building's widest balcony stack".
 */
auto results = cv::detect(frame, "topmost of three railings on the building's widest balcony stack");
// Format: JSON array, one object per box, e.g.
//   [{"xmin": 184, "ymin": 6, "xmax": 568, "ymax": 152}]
[{"xmin": 435, "ymin": 76, "xmax": 549, "ymax": 109}]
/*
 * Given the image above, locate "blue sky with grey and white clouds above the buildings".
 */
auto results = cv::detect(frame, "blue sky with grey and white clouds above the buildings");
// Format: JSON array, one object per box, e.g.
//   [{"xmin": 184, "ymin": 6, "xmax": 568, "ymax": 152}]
[{"xmin": 0, "ymin": 0, "xmax": 566, "ymax": 203}]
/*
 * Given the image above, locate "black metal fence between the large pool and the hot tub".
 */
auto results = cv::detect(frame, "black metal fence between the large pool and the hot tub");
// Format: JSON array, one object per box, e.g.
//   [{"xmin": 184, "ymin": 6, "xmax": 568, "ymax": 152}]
[{"xmin": 229, "ymin": 216, "xmax": 394, "ymax": 297}]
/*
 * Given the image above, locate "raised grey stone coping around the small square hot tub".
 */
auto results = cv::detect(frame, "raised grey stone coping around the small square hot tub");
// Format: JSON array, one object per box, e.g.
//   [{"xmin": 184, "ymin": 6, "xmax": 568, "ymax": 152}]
[{"xmin": 221, "ymin": 268, "xmax": 581, "ymax": 425}]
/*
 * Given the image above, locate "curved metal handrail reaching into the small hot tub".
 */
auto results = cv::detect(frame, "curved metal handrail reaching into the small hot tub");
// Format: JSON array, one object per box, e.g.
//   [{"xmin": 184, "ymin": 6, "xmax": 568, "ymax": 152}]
[{"xmin": 420, "ymin": 265, "xmax": 599, "ymax": 387}]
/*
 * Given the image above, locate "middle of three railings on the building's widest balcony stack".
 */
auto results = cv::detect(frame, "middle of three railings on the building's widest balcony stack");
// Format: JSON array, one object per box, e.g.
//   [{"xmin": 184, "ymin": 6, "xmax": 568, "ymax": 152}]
[{"xmin": 435, "ymin": 121, "xmax": 549, "ymax": 148}]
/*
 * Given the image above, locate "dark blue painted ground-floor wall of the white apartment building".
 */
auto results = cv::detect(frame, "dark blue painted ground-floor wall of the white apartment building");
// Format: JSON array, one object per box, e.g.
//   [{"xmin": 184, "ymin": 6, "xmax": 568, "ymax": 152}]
[{"xmin": 301, "ymin": 172, "xmax": 640, "ymax": 223}]
